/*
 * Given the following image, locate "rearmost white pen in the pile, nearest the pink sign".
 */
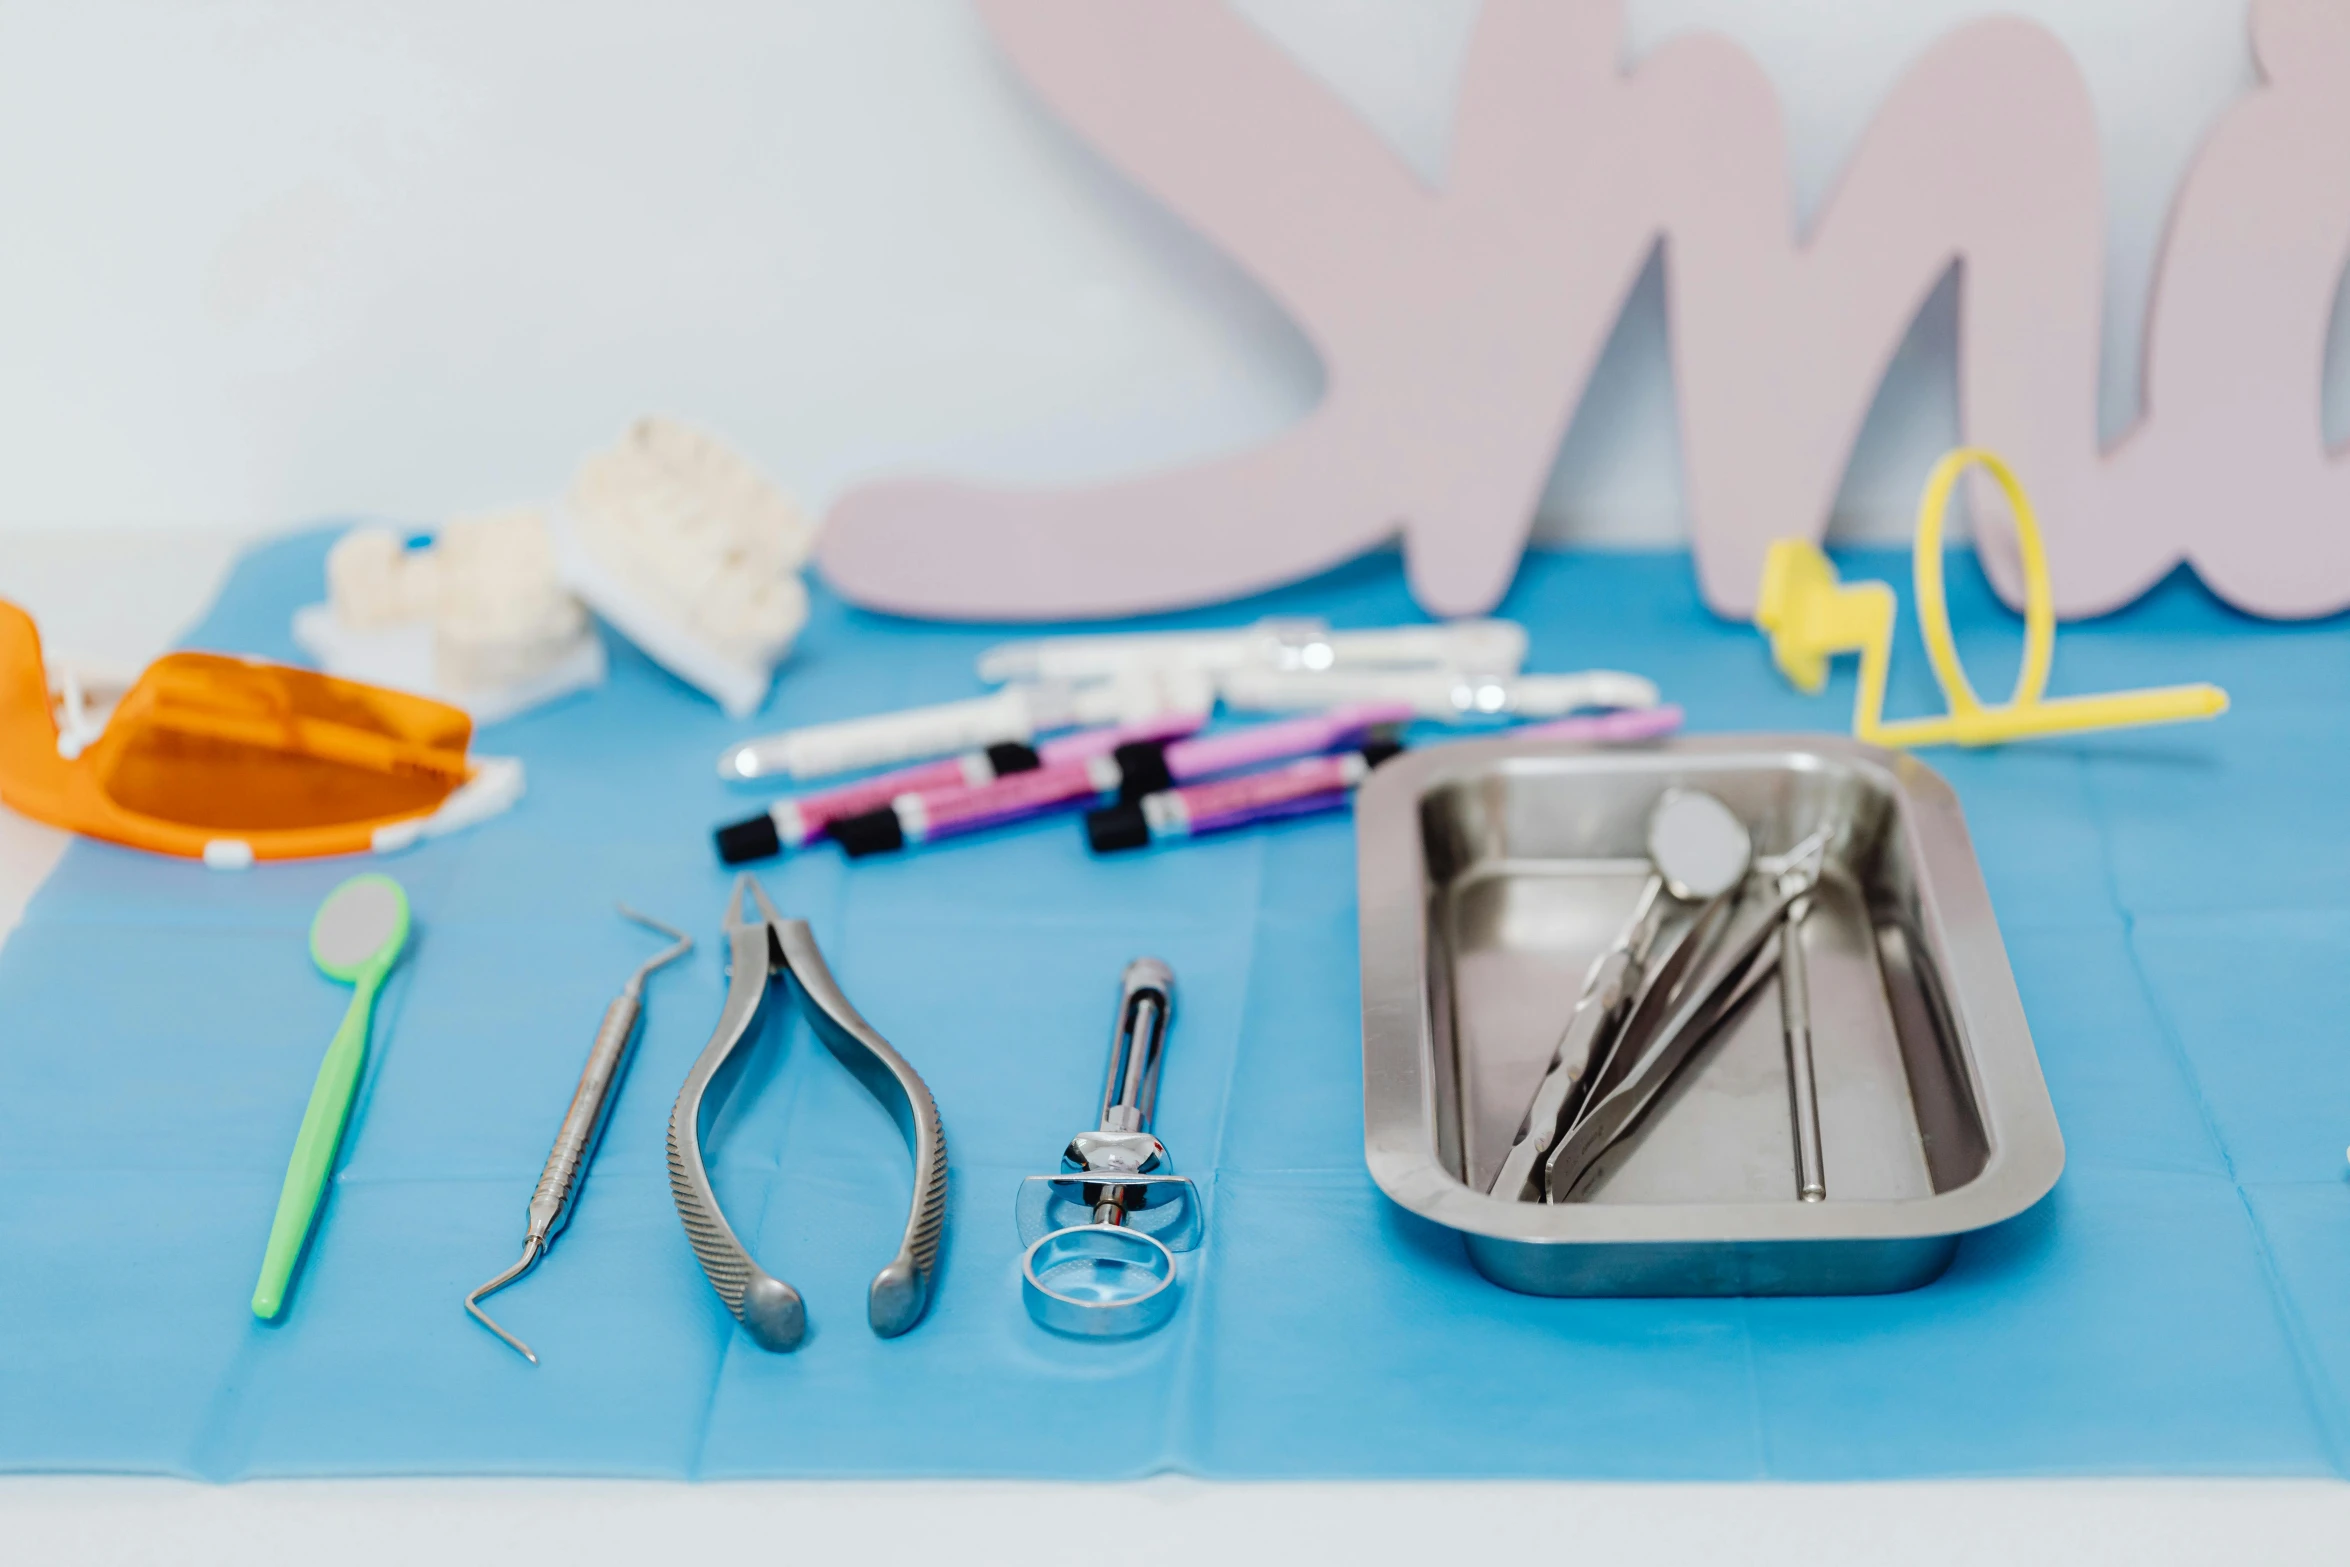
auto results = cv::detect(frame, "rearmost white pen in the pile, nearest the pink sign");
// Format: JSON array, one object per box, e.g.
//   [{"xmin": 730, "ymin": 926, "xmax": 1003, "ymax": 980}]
[{"xmin": 980, "ymin": 618, "xmax": 1525, "ymax": 681}]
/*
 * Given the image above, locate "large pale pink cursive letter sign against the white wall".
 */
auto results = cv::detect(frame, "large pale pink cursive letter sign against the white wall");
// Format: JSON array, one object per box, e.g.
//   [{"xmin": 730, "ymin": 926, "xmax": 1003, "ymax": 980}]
[{"xmin": 820, "ymin": 0, "xmax": 2350, "ymax": 618}]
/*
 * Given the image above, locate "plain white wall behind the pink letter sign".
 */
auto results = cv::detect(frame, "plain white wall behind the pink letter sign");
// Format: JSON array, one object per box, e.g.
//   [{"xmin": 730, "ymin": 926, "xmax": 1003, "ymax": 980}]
[{"xmin": 0, "ymin": 0, "xmax": 2350, "ymax": 552}]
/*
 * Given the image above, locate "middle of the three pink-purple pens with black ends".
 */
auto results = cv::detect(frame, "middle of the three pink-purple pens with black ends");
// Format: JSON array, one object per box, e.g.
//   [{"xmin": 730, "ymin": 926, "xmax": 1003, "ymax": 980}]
[{"xmin": 830, "ymin": 702, "xmax": 1410, "ymax": 860}]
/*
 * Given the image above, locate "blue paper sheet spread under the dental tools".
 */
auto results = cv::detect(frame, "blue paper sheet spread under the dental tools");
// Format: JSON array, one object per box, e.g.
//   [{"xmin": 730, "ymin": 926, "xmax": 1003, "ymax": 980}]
[{"xmin": 0, "ymin": 536, "xmax": 2350, "ymax": 1480}]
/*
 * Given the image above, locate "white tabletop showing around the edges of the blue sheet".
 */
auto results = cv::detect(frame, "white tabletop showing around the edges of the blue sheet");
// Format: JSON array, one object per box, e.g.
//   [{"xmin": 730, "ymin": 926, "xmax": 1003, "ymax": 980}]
[{"xmin": 0, "ymin": 531, "xmax": 2350, "ymax": 1567}]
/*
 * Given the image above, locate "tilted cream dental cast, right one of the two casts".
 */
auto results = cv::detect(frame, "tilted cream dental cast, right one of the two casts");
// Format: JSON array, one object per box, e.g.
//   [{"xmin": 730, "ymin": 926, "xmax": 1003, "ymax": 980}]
[{"xmin": 557, "ymin": 418, "xmax": 815, "ymax": 719}]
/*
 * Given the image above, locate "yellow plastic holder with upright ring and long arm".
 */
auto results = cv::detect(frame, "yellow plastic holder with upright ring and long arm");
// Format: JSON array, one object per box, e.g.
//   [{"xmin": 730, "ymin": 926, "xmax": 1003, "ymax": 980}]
[{"xmin": 1755, "ymin": 446, "xmax": 2228, "ymax": 745}]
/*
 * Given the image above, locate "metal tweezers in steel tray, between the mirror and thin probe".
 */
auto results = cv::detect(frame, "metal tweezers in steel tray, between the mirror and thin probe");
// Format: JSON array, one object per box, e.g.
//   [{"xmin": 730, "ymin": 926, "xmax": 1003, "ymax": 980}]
[{"xmin": 1544, "ymin": 829, "xmax": 1831, "ymax": 1203}]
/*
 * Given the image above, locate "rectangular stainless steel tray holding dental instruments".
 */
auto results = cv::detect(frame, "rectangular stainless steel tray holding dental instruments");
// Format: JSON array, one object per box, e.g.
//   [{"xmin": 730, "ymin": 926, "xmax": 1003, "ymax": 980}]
[{"xmin": 1356, "ymin": 735, "xmax": 2063, "ymax": 1294}]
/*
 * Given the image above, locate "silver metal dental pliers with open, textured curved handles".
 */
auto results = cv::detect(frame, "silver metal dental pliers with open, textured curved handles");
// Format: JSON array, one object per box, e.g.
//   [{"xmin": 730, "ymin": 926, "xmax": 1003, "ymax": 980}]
[{"xmin": 670, "ymin": 874, "xmax": 947, "ymax": 1351}]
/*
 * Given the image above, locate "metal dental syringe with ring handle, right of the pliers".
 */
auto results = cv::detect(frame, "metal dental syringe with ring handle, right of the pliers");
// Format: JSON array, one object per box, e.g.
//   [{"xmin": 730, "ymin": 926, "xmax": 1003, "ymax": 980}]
[{"xmin": 1013, "ymin": 959, "xmax": 1201, "ymax": 1339}]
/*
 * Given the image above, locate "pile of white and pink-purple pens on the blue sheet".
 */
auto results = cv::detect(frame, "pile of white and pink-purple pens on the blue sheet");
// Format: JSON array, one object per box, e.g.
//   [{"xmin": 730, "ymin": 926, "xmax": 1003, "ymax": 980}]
[{"xmin": 717, "ymin": 620, "xmax": 1680, "ymax": 865}]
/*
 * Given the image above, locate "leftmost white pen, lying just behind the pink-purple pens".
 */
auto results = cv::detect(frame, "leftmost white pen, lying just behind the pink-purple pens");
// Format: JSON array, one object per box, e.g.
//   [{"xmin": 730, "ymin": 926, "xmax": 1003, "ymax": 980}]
[{"xmin": 719, "ymin": 670, "xmax": 1215, "ymax": 782}]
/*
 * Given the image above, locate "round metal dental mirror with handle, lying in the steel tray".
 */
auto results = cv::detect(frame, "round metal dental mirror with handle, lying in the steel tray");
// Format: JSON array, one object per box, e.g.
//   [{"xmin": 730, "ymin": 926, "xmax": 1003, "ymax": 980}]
[{"xmin": 1490, "ymin": 787, "xmax": 1753, "ymax": 1201}]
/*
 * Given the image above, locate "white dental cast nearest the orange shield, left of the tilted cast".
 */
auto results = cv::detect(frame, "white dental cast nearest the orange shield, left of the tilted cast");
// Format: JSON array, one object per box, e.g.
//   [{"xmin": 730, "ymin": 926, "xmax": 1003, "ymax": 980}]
[{"xmin": 294, "ymin": 507, "xmax": 604, "ymax": 724}]
